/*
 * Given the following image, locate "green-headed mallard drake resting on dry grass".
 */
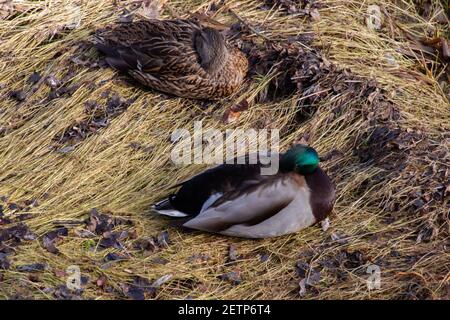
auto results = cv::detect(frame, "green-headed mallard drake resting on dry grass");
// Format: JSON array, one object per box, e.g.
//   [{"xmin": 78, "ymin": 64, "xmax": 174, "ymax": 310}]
[{"xmin": 152, "ymin": 145, "xmax": 335, "ymax": 238}]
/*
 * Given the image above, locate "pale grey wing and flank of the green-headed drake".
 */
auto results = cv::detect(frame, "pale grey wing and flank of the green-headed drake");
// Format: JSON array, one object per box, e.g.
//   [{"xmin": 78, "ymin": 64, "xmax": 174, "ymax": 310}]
[{"xmin": 184, "ymin": 173, "xmax": 316, "ymax": 238}]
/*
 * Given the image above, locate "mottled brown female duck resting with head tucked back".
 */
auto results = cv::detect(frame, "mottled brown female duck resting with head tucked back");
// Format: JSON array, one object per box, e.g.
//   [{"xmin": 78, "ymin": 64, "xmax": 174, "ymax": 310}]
[{"xmin": 95, "ymin": 19, "xmax": 248, "ymax": 99}]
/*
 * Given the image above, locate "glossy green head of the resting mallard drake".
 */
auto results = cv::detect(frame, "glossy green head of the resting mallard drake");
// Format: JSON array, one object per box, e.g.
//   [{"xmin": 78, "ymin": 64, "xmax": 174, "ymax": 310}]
[{"xmin": 280, "ymin": 144, "xmax": 319, "ymax": 175}]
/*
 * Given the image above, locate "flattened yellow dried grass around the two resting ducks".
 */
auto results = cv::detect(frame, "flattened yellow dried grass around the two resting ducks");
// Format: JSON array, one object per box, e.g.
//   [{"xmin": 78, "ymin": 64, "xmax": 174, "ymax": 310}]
[{"xmin": 0, "ymin": 0, "xmax": 450, "ymax": 299}]
